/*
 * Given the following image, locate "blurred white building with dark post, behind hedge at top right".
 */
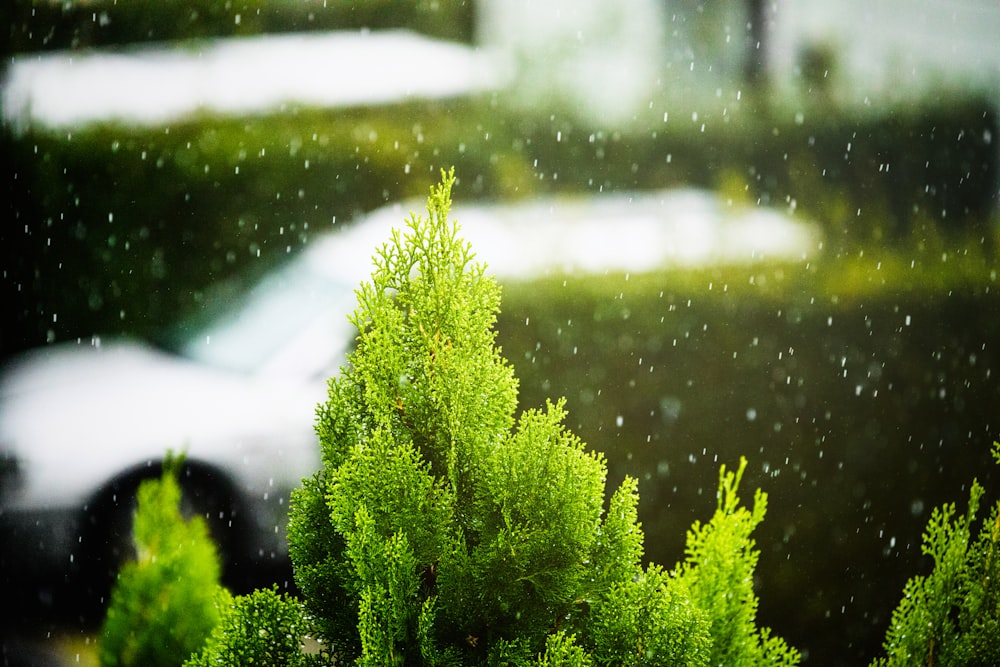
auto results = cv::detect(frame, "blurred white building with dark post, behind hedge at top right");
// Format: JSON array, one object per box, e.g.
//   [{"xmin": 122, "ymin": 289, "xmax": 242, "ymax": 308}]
[{"xmin": 479, "ymin": 0, "xmax": 1000, "ymax": 123}]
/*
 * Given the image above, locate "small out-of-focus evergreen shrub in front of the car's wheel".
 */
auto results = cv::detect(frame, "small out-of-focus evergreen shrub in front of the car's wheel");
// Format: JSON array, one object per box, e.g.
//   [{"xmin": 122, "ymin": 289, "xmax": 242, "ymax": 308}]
[{"xmin": 99, "ymin": 456, "xmax": 221, "ymax": 667}]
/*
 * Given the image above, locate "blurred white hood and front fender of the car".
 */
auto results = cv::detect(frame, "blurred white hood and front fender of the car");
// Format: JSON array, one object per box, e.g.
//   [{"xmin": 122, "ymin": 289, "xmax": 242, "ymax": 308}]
[{"xmin": 0, "ymin": 340, "xmax": 322, "ymax": 511}]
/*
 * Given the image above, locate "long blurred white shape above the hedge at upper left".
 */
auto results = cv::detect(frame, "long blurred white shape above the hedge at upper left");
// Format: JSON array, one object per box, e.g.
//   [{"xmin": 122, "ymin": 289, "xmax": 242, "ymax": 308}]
[{"xmin": 3, "ymin": 30, "xmax": 503, "ymax": 127}]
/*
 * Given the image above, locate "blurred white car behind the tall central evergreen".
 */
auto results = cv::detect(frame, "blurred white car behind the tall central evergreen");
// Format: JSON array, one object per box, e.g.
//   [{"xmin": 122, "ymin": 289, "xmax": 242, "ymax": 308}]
[{"xmin": 0, "ymin": 190, "xmax": 817, "ymax": 612}]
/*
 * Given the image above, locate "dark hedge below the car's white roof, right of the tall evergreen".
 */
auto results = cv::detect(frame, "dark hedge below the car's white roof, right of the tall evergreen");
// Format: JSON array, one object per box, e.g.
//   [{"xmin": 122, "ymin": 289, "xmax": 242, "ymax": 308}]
[{"xmin": 497, "ymin": 260, "xmax": 1000, "ymax": 665}]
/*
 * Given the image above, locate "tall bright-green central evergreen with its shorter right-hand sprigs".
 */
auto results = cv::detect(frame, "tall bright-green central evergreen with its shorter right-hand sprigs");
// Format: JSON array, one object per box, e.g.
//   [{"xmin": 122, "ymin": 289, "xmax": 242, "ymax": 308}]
[{"xmin": 282, "ymin": 172, "xmax": 798, "ymax": 667}]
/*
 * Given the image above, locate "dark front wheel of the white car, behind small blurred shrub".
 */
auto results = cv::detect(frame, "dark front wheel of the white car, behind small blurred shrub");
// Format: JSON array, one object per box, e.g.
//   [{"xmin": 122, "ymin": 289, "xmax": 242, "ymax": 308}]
[{"xmin": 72, "ymin": 462, "xmax": 246, "ymax": 618}]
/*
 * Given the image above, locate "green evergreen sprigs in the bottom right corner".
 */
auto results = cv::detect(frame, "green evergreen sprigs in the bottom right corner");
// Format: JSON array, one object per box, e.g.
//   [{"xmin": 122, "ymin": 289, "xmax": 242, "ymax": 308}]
[{"xmin": 872, "ymin": 443, "xmax": 1000, "ymax": 667}]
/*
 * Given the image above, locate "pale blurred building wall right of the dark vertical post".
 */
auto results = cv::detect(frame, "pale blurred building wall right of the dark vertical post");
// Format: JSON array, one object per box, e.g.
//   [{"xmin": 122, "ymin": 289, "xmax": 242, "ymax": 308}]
[{"xmin": 768, "ymin": 0, "xmax": 1000, "ymax": 107}]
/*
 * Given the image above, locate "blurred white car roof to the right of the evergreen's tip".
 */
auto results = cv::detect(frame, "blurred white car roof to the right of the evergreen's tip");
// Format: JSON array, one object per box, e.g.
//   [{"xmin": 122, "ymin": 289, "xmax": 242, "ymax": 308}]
[{"xmin": 451, "ymin": 190, "xmax": 819, "ymax": 277}]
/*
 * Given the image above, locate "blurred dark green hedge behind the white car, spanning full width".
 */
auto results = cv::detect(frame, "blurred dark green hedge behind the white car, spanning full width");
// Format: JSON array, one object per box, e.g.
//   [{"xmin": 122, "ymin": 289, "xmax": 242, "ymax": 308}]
[{"xmin": 0, "ymin": 95, "xmax": 1000, "ymax": 353}]
